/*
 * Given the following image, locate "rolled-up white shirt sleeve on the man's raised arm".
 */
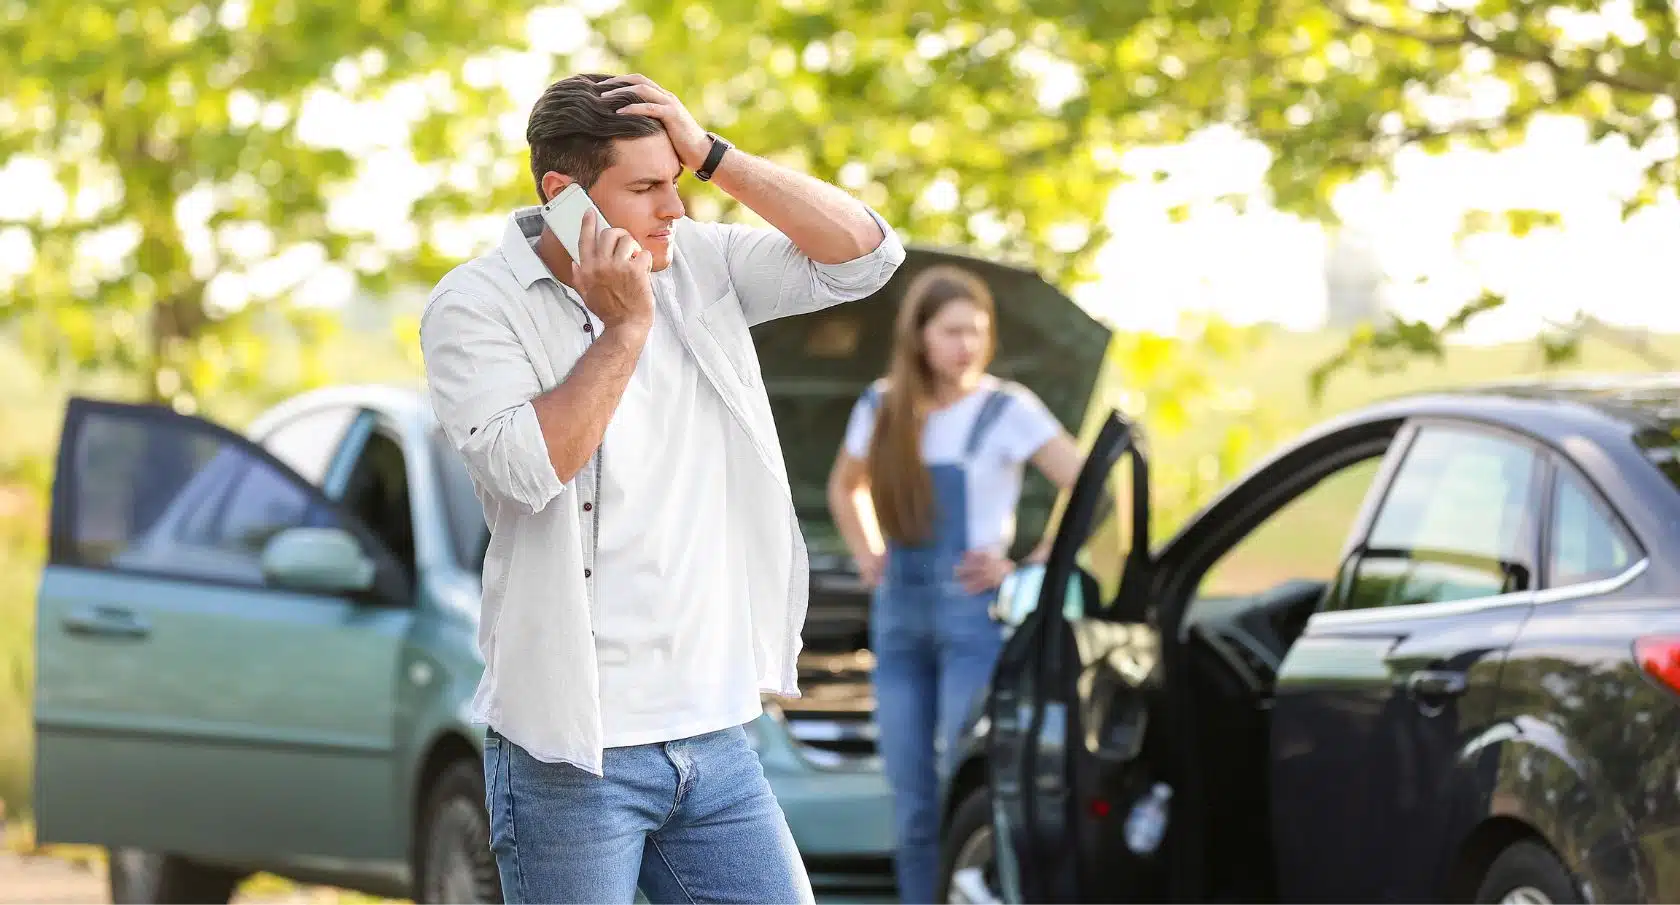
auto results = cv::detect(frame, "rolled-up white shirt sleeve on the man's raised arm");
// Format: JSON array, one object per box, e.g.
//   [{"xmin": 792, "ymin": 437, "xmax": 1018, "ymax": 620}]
[{"xmin": 714, "ymin": 207, "xmax": 904, "ymax": 324}]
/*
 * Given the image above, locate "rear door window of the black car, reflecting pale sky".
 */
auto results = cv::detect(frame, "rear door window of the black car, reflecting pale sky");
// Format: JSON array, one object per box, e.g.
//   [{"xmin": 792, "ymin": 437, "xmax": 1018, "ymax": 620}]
[{"xmin": 1336, "ymin": 425, "xmax": 1539, "ymax": 609}]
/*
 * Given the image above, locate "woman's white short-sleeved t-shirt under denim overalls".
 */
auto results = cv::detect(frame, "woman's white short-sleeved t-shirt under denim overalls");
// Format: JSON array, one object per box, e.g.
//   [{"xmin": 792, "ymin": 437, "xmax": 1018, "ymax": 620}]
[{"xmin": 845, "ymin": 374, "xmax": 1062, "ymax": 552}]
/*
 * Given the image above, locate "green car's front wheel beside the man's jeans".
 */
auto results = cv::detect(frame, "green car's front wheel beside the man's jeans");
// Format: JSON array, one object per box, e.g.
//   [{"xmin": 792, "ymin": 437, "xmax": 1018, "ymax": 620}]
[{"xmin": 415, "ymin": 761, "xmax": 502, "ymax": 903}]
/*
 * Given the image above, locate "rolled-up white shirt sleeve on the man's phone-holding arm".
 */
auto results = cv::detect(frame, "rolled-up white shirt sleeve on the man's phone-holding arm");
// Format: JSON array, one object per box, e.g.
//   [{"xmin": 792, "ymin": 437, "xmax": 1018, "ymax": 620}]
[{"xmin": 420, "ymin": 290, "xmax": 564, "ymax": 512}]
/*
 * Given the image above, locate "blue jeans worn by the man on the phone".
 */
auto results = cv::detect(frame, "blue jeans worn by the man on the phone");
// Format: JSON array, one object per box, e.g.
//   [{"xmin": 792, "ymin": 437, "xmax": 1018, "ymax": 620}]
[{"xmin": 484, "ymin": 727, "xmax": 813, "ymax": 903}]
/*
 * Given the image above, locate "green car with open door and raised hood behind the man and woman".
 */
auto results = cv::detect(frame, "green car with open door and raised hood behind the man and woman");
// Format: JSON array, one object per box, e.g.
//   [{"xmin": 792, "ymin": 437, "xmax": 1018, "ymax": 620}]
[{"xmin": 35, "ymin": 252, "xmax": 1107, "ymax": 902}]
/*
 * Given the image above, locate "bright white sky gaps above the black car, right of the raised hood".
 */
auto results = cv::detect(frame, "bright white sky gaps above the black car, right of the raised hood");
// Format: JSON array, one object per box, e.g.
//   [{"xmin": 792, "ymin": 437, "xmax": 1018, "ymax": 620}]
[{"xmin": 1079, "ymin": 118, "xmax": 1680, "ymax": 341}]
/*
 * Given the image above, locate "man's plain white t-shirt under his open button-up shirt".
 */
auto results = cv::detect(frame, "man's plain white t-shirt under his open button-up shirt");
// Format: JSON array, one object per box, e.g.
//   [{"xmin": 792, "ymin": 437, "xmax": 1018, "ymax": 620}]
[{"xmin": 585, "ymin": 293, "xmax": 763, "ymax": 747}]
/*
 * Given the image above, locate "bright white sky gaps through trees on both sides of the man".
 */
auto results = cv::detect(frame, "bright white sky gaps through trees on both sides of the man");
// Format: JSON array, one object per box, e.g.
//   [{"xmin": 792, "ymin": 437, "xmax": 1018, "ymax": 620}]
[{"xmin": 0, "ymin": 0, "xmax": 1680, "ymax": 341}]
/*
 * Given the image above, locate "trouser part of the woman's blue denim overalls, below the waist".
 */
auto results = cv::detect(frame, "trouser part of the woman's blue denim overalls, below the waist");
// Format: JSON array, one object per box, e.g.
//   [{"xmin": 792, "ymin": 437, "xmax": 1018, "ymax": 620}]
[{"xmin": 870, "ymin": 577, "xmax": 1003, "ymax": 902}]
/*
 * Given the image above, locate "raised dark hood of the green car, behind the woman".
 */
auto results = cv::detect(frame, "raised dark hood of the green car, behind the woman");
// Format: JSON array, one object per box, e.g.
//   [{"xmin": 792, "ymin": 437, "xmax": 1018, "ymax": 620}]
[{"xmin": 753, "ymin": 248, "xmax": 1110, "ymax": 571}]
